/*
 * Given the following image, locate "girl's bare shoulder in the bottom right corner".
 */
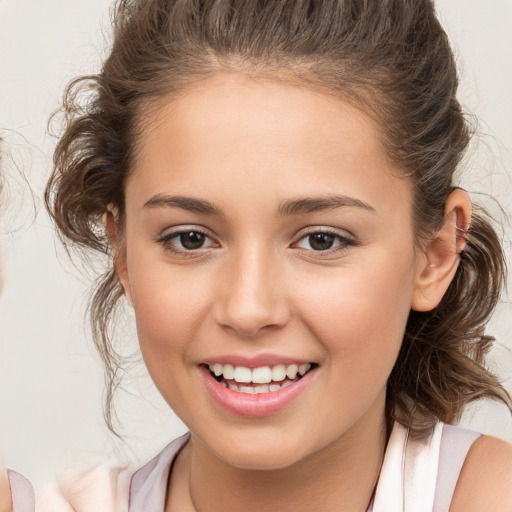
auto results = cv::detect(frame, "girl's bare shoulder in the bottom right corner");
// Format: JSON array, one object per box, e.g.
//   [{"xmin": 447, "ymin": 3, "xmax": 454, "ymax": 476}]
[{"xmin": 450, "ymin": 436, "xmax": 512, "ymax": 512}]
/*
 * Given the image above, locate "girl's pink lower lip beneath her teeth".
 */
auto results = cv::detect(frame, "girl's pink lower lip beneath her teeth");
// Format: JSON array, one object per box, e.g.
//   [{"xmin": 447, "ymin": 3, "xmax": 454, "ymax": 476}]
[{"xmin": 199, "ymin": 366, "xmax": 315, "ymax": 418}]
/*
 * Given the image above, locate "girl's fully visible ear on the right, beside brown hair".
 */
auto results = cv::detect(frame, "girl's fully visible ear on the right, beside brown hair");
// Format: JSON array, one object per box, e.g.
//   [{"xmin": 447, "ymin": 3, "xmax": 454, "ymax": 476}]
[{"xmin": 411, "ymin": 189, "xmax": 471, "ymax": 311}]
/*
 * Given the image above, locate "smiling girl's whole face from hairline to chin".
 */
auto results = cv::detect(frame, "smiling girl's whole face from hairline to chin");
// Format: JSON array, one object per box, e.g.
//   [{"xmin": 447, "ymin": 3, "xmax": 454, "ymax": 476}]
[{"xmin": 117, "ymin": 74, "xmax": 424, "ymax": 468}]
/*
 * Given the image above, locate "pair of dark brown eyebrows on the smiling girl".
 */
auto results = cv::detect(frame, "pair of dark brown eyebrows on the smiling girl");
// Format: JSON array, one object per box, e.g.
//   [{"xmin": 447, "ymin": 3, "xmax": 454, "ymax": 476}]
[{"xmin": 144, "ymin": 194, "xmax": 375, "ymax": 216}]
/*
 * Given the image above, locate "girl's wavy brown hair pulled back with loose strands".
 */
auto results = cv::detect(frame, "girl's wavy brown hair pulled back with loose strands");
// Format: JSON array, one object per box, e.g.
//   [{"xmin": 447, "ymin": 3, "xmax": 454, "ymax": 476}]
[{"xmin": 46, "ymin": 0, "xmax": 511, "ymax": 429}]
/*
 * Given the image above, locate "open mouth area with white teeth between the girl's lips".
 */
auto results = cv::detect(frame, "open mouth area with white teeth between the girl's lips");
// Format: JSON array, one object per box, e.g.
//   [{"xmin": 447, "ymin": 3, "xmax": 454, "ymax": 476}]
[{"xmin": 204, "ymin": 363, "xmax": 318, "ymax": 395}]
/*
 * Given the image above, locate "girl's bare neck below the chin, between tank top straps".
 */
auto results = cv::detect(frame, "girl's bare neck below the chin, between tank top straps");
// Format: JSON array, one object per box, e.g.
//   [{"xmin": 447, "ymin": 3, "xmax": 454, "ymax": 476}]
[{"xmin": 167, "ymin": 400, "xmax": 387, "ymax": 512}]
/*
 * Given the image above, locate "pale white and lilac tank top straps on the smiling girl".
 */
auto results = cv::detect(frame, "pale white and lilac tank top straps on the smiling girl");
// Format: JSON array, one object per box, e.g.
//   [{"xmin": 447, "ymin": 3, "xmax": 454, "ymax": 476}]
[{"xmin": 128, "ymin": 423, "xmax": 481, "ymax": 512}]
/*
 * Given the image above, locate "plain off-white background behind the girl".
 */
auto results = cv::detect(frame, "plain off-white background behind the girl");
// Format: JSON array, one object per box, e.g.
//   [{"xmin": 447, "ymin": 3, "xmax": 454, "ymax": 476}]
[{"xmin": 0, "ymin": 0, "xmax": 512, "ymax": 480}]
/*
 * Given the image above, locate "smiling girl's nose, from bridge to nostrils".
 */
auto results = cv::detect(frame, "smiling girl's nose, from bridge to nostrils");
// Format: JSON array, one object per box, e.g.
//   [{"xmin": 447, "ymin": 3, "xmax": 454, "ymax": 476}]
[{"xmin": 215, "ymin": 243, "xmax": 290, "ymax": 337}]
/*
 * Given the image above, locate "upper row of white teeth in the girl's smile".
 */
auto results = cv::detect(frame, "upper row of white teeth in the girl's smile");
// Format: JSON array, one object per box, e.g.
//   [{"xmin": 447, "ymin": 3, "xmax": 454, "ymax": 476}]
[{"xmin": 208, "ymin": 363, "xmax": 311, "ymax": 384}]
